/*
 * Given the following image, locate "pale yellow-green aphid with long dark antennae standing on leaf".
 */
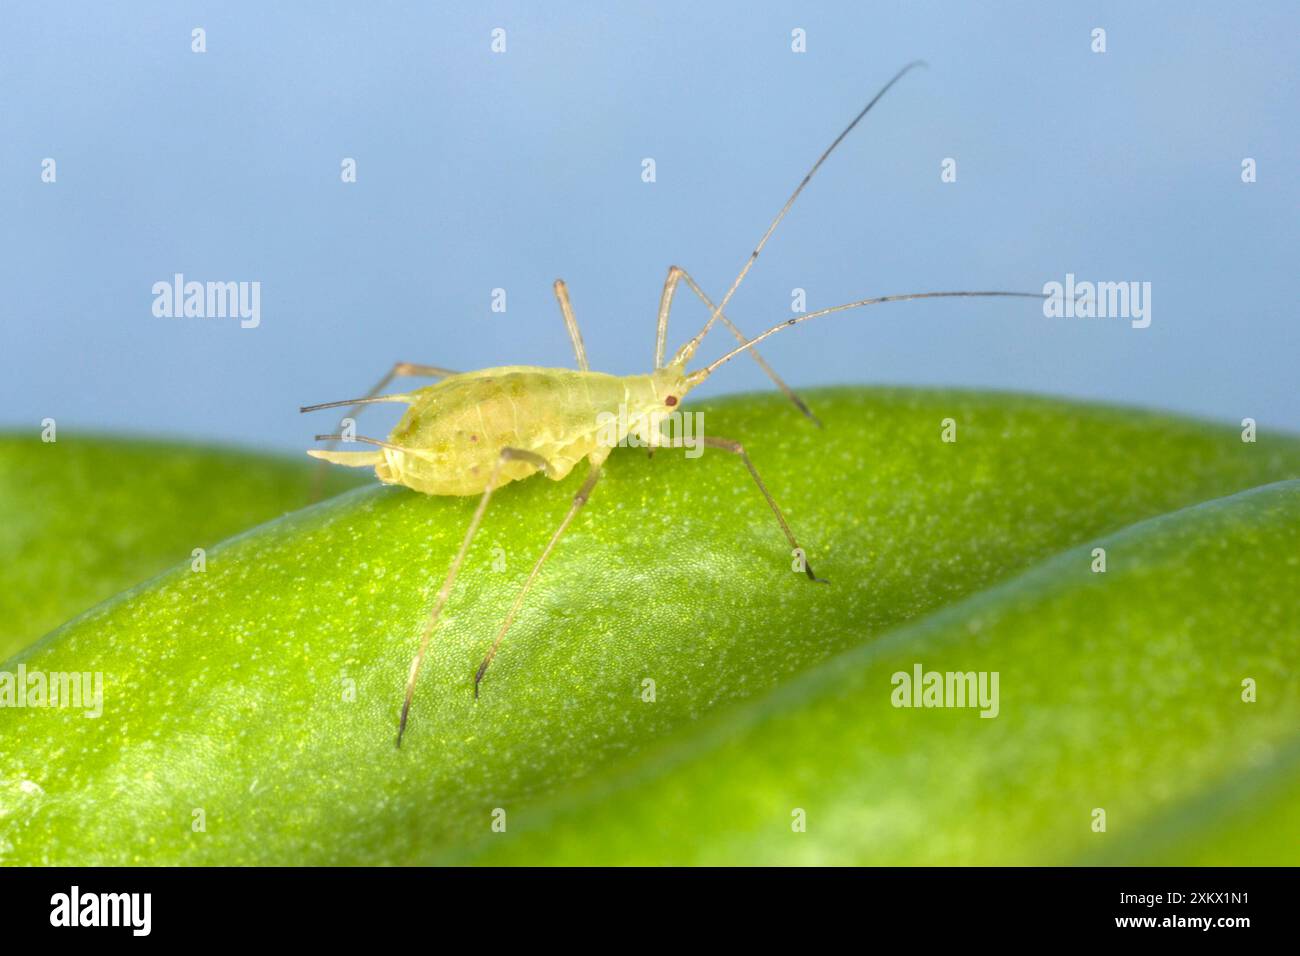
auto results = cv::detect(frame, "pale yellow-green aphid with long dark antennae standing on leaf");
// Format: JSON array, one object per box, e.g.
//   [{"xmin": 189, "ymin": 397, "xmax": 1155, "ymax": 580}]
[{"xmin": 302, "ymin": 61, "xmax": 1043, "ymax": 747}]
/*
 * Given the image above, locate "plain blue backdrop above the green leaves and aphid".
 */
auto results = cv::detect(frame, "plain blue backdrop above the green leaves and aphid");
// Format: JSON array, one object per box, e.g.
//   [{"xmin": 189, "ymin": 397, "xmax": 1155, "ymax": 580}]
[{"xmin": 0, "ymin": 0, "xmax": 1300, "ymax": 450}]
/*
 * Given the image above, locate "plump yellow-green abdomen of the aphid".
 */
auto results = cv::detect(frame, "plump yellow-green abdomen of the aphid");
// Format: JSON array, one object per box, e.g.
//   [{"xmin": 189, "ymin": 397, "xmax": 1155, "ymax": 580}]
[{"xmin": 376, "ymin": 365, "xmax": 644, "ymax": 496}]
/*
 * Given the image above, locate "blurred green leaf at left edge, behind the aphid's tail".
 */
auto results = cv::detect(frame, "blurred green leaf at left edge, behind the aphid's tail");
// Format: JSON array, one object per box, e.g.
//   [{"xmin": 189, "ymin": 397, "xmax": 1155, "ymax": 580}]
[{"xmin": 0, "ymin": 429, "xmax": 358, "ymax": 661}]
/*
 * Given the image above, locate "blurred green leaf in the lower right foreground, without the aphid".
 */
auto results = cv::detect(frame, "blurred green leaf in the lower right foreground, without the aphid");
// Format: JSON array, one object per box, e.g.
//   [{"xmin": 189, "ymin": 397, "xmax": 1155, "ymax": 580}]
[{"xmin": 454, "ymin": 481, "xmax": 1300, "ymax": 865}]
